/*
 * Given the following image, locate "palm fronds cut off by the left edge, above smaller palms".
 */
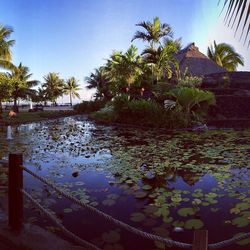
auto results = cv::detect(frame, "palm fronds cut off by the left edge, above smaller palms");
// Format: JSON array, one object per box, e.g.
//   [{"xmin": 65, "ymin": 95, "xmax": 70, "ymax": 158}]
[{"xmin": 0, "ymin": 24, "xmax": 15, "ymax": 69}]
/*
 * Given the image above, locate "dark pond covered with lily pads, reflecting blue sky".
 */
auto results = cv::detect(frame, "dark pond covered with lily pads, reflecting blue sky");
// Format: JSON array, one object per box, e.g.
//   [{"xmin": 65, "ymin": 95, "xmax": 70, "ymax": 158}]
[{"xmin": 0, "ymin": 116, "xmax": 250, "ymax": 250}]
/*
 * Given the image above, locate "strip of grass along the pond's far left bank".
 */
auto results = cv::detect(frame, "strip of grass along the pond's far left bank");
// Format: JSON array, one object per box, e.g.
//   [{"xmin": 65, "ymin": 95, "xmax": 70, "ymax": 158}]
[{"xmin": 0, "ymin": 110, "xmax": 76, "ymax": 125}]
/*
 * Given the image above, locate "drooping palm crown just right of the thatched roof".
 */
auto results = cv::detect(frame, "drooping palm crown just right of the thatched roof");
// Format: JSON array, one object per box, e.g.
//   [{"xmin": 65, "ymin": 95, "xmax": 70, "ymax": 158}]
[{"xmin": 207, "ymin": 41, "xmax": 244, "ymax": 71}]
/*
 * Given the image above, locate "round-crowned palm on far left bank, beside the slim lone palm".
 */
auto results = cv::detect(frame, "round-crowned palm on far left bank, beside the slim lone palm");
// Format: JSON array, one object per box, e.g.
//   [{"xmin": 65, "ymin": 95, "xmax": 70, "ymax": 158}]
[{"xmin": 42, "ymin": 72, "xmax": 65, "ymax": 105}]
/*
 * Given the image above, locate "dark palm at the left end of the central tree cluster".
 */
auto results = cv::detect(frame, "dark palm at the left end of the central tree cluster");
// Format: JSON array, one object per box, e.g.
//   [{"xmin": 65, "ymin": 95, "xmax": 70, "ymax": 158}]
[{"xmin": 85, "ymin": 67, "xmax": 112, "ymax": 100}]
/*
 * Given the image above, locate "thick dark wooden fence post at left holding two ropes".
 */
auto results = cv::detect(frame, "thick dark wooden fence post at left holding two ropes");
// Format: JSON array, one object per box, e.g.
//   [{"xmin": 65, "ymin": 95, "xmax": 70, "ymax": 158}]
[{"xmin": 9, "ymin": 154, "xmax": 23, "ymax": 231}]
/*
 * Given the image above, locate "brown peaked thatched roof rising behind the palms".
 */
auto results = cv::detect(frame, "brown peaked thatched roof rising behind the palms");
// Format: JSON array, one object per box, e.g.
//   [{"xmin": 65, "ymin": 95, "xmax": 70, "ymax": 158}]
[{"xmin": 175, "ymin": 43, "xmax": 227, "ymax": 76}]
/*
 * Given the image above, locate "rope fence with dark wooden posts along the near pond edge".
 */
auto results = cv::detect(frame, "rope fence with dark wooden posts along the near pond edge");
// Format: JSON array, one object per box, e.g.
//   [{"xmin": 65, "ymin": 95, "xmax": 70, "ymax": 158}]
[{"xmin": 6, "ymin": 154, "xmax": 250, "ymax": 250}]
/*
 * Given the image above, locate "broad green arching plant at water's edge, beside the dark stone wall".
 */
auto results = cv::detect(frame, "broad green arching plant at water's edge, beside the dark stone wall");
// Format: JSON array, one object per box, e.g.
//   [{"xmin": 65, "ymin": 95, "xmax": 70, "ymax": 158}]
[{"xmin": 169, "ymin": 87, "xmax": 215, "ymax": 125}]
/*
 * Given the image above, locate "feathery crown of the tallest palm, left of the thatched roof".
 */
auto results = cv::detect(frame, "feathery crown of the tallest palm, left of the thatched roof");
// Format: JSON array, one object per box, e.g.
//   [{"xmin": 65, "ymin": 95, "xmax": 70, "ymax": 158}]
[{"xmin": 132, "ymin": 17, "xmax": 173, "ymax": 48}]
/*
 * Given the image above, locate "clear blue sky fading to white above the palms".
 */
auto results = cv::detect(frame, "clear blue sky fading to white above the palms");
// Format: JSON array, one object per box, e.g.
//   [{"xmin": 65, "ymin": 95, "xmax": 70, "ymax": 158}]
[{"xmin": 0, "ymin": 0, "xmax": 250, "ymax": 102}]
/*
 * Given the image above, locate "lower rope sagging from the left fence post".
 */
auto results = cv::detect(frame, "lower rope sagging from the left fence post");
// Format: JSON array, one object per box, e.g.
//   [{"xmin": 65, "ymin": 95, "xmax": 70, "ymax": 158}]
[{"xmin": 21, "ymin": 189, "xmax": 101, "ymax": 250}]
